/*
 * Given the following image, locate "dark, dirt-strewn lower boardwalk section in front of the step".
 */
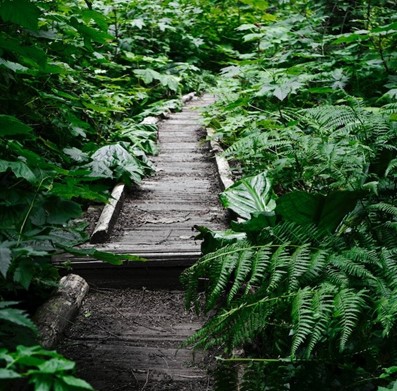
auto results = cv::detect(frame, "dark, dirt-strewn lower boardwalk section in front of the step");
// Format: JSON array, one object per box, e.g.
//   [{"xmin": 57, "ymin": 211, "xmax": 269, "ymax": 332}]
[{"xmin": 58, "ymin": 289, "xmax": 208, "ymax": 391}]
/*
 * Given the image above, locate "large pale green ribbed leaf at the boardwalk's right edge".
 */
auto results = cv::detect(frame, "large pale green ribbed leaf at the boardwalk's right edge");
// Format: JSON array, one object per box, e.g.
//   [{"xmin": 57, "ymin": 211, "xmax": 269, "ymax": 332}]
[{"xmin": 220, "ymin": 172, "xmax": 276, "ymax": 219}]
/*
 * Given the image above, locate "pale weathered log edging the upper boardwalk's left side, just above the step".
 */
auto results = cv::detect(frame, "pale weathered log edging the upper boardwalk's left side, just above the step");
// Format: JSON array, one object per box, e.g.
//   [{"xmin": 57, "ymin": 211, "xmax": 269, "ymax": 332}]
[{"xmin": 90, "ymin": 184, "xmax": 125, "ymax": 243}]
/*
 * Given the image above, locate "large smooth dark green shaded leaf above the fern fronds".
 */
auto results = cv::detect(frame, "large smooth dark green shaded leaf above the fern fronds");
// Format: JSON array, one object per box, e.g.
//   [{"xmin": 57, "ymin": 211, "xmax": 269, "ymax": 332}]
[{"xmin": 276, "ymin": 191, "xmax": 360, "ymax": 232}]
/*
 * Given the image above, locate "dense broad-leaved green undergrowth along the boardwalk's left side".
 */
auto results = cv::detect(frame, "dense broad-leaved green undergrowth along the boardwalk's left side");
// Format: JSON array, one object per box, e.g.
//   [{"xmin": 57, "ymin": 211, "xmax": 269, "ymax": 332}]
[{"xmin": 0, "ymin": 0, "xmax": 235, "ymax": 390}]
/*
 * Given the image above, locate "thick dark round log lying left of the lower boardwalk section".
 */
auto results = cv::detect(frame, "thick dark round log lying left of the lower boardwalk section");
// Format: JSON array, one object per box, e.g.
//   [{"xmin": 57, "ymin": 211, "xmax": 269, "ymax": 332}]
[{"xmin": 33, "ymin": 274, "xmax": 89, "ymax": 349}]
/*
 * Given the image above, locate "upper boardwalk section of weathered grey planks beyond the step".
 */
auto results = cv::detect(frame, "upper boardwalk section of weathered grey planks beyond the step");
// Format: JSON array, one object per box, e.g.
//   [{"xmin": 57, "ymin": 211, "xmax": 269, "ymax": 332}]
[{"xmin": 107, "ymin": 96, "xmax": 225, "ymax": 259}]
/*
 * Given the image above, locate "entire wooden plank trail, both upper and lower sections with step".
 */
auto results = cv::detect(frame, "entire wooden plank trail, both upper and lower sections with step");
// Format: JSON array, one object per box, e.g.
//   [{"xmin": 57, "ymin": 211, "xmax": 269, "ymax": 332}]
[{"xmin": 59, "ymin": 96, "xmax": 226, "ymax": 391}]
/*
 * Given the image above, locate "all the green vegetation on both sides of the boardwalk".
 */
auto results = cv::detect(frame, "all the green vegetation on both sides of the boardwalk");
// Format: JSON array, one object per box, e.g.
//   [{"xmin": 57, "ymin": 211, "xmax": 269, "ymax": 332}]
[{"xmin": 0, "ymin": 0, "xmax": 397, "ymax": 391}]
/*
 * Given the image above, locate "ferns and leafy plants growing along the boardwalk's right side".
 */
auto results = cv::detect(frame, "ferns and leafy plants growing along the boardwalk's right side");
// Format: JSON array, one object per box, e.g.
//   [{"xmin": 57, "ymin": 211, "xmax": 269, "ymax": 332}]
[{"xmin": 182, "ymin": 1, "xmax": 397, "ymax": 390}]
